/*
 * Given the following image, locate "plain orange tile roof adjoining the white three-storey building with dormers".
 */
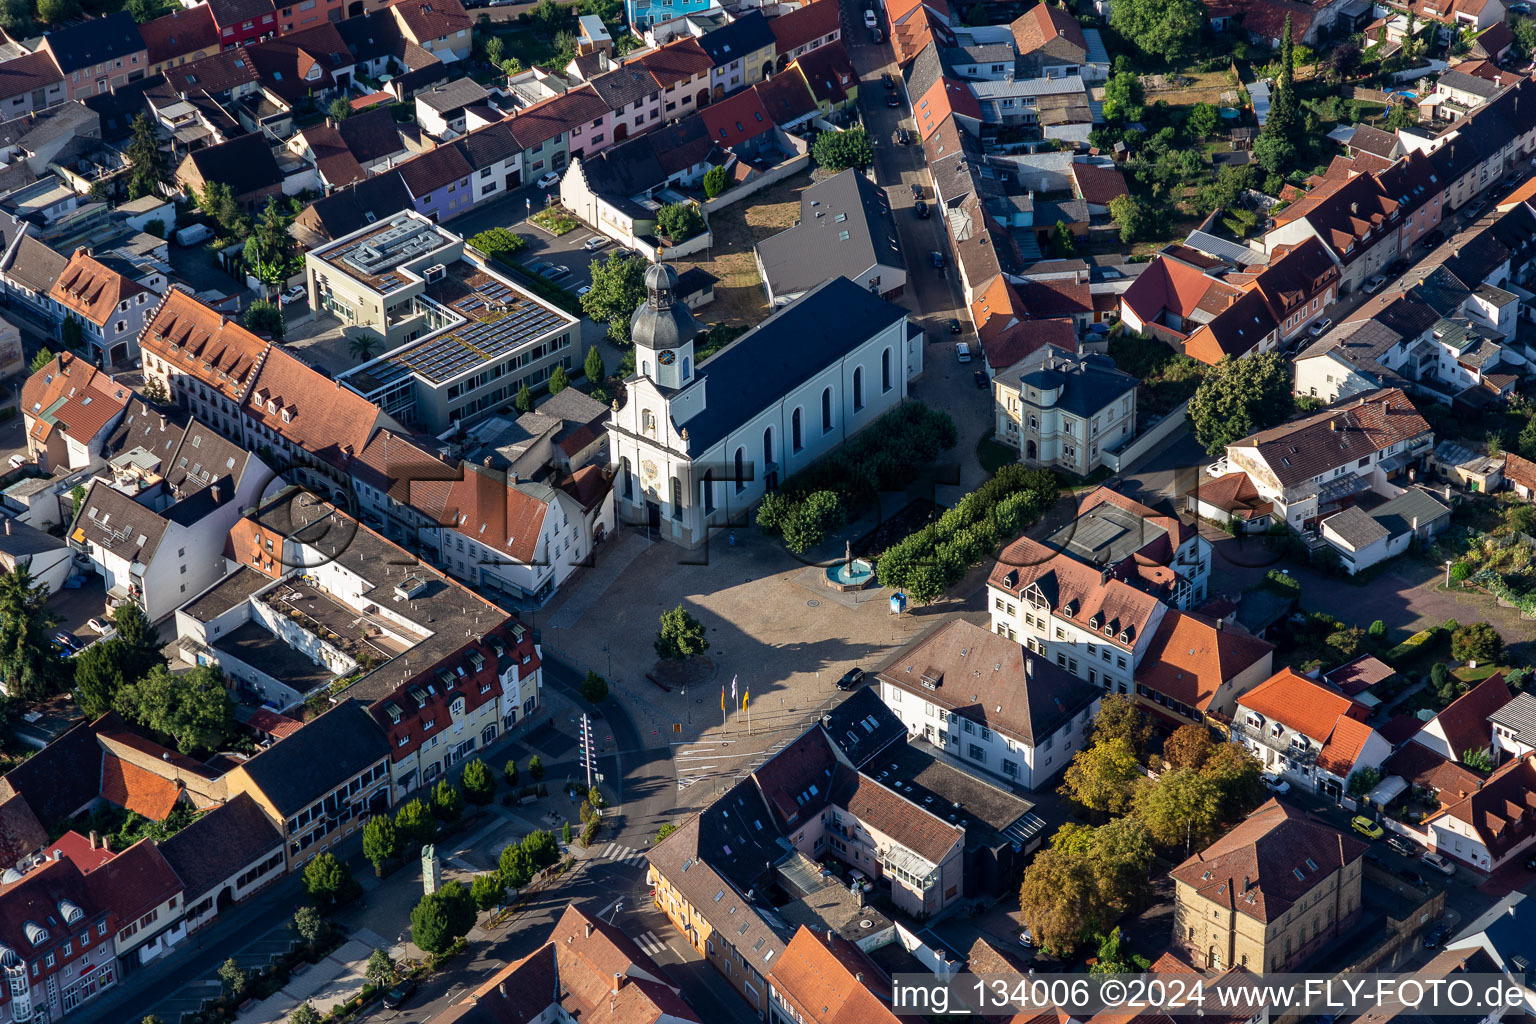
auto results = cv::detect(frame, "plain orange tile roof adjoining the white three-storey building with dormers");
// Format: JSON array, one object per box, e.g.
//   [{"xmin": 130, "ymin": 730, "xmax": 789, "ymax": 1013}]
[{"xmin": 1137, "ymin": 609, "xmax": 1275, "ymax": 711}]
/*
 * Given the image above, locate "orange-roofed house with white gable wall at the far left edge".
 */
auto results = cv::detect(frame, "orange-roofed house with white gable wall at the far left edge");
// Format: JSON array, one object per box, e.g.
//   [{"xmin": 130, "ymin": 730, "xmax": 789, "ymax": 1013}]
[{"xmin": 22, "ymin": 352, "xmax": 132, "ymax": 473}]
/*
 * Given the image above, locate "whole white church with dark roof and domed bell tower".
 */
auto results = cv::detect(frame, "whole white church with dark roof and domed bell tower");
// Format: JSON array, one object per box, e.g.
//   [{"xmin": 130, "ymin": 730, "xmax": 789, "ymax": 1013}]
[{"xmin": 608, "ymin": 264, "xmax": 925, "ymax": 548}]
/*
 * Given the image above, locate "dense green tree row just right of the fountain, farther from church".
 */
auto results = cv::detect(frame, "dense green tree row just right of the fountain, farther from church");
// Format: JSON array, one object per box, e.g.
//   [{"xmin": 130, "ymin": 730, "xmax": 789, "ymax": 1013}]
[{"xmin": 876, "ymin": 465, "xmax": 1057, "ymax": 603}]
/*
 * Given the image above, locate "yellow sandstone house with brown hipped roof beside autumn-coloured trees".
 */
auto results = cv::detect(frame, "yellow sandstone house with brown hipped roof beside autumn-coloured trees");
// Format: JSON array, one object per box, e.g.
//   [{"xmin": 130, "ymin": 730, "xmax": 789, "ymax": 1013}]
[{"xmin": 1169, "ymin": 800, "xmax": 1366, "ymax": 976}]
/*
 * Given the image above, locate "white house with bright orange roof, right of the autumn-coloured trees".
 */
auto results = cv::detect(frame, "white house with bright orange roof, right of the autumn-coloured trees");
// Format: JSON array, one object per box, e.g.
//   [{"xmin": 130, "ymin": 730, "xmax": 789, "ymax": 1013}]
[{"xmin": 1232, "ymin": 668, "xmax": 1392, "ymax": 798}]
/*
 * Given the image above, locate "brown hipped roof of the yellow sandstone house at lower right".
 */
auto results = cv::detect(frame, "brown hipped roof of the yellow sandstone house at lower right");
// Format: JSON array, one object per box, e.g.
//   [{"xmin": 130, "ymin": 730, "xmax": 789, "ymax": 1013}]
[{"xmin": 1169, "ymin": 800, "xmax": 1366, "ymax": 923}]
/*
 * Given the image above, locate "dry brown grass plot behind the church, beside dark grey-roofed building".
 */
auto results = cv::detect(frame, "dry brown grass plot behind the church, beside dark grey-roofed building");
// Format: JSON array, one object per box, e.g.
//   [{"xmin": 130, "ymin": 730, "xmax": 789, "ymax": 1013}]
[{"xmin": 677, "ymin": 173, "xmax": 811, "ymax": 327}]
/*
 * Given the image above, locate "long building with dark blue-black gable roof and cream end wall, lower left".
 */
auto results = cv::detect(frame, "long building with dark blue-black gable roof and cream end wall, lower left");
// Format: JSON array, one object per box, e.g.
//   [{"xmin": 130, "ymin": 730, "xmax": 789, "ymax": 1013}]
[{"xmin": 224, "ymin": 697, "xmax": 390, "ymax": 872}]
